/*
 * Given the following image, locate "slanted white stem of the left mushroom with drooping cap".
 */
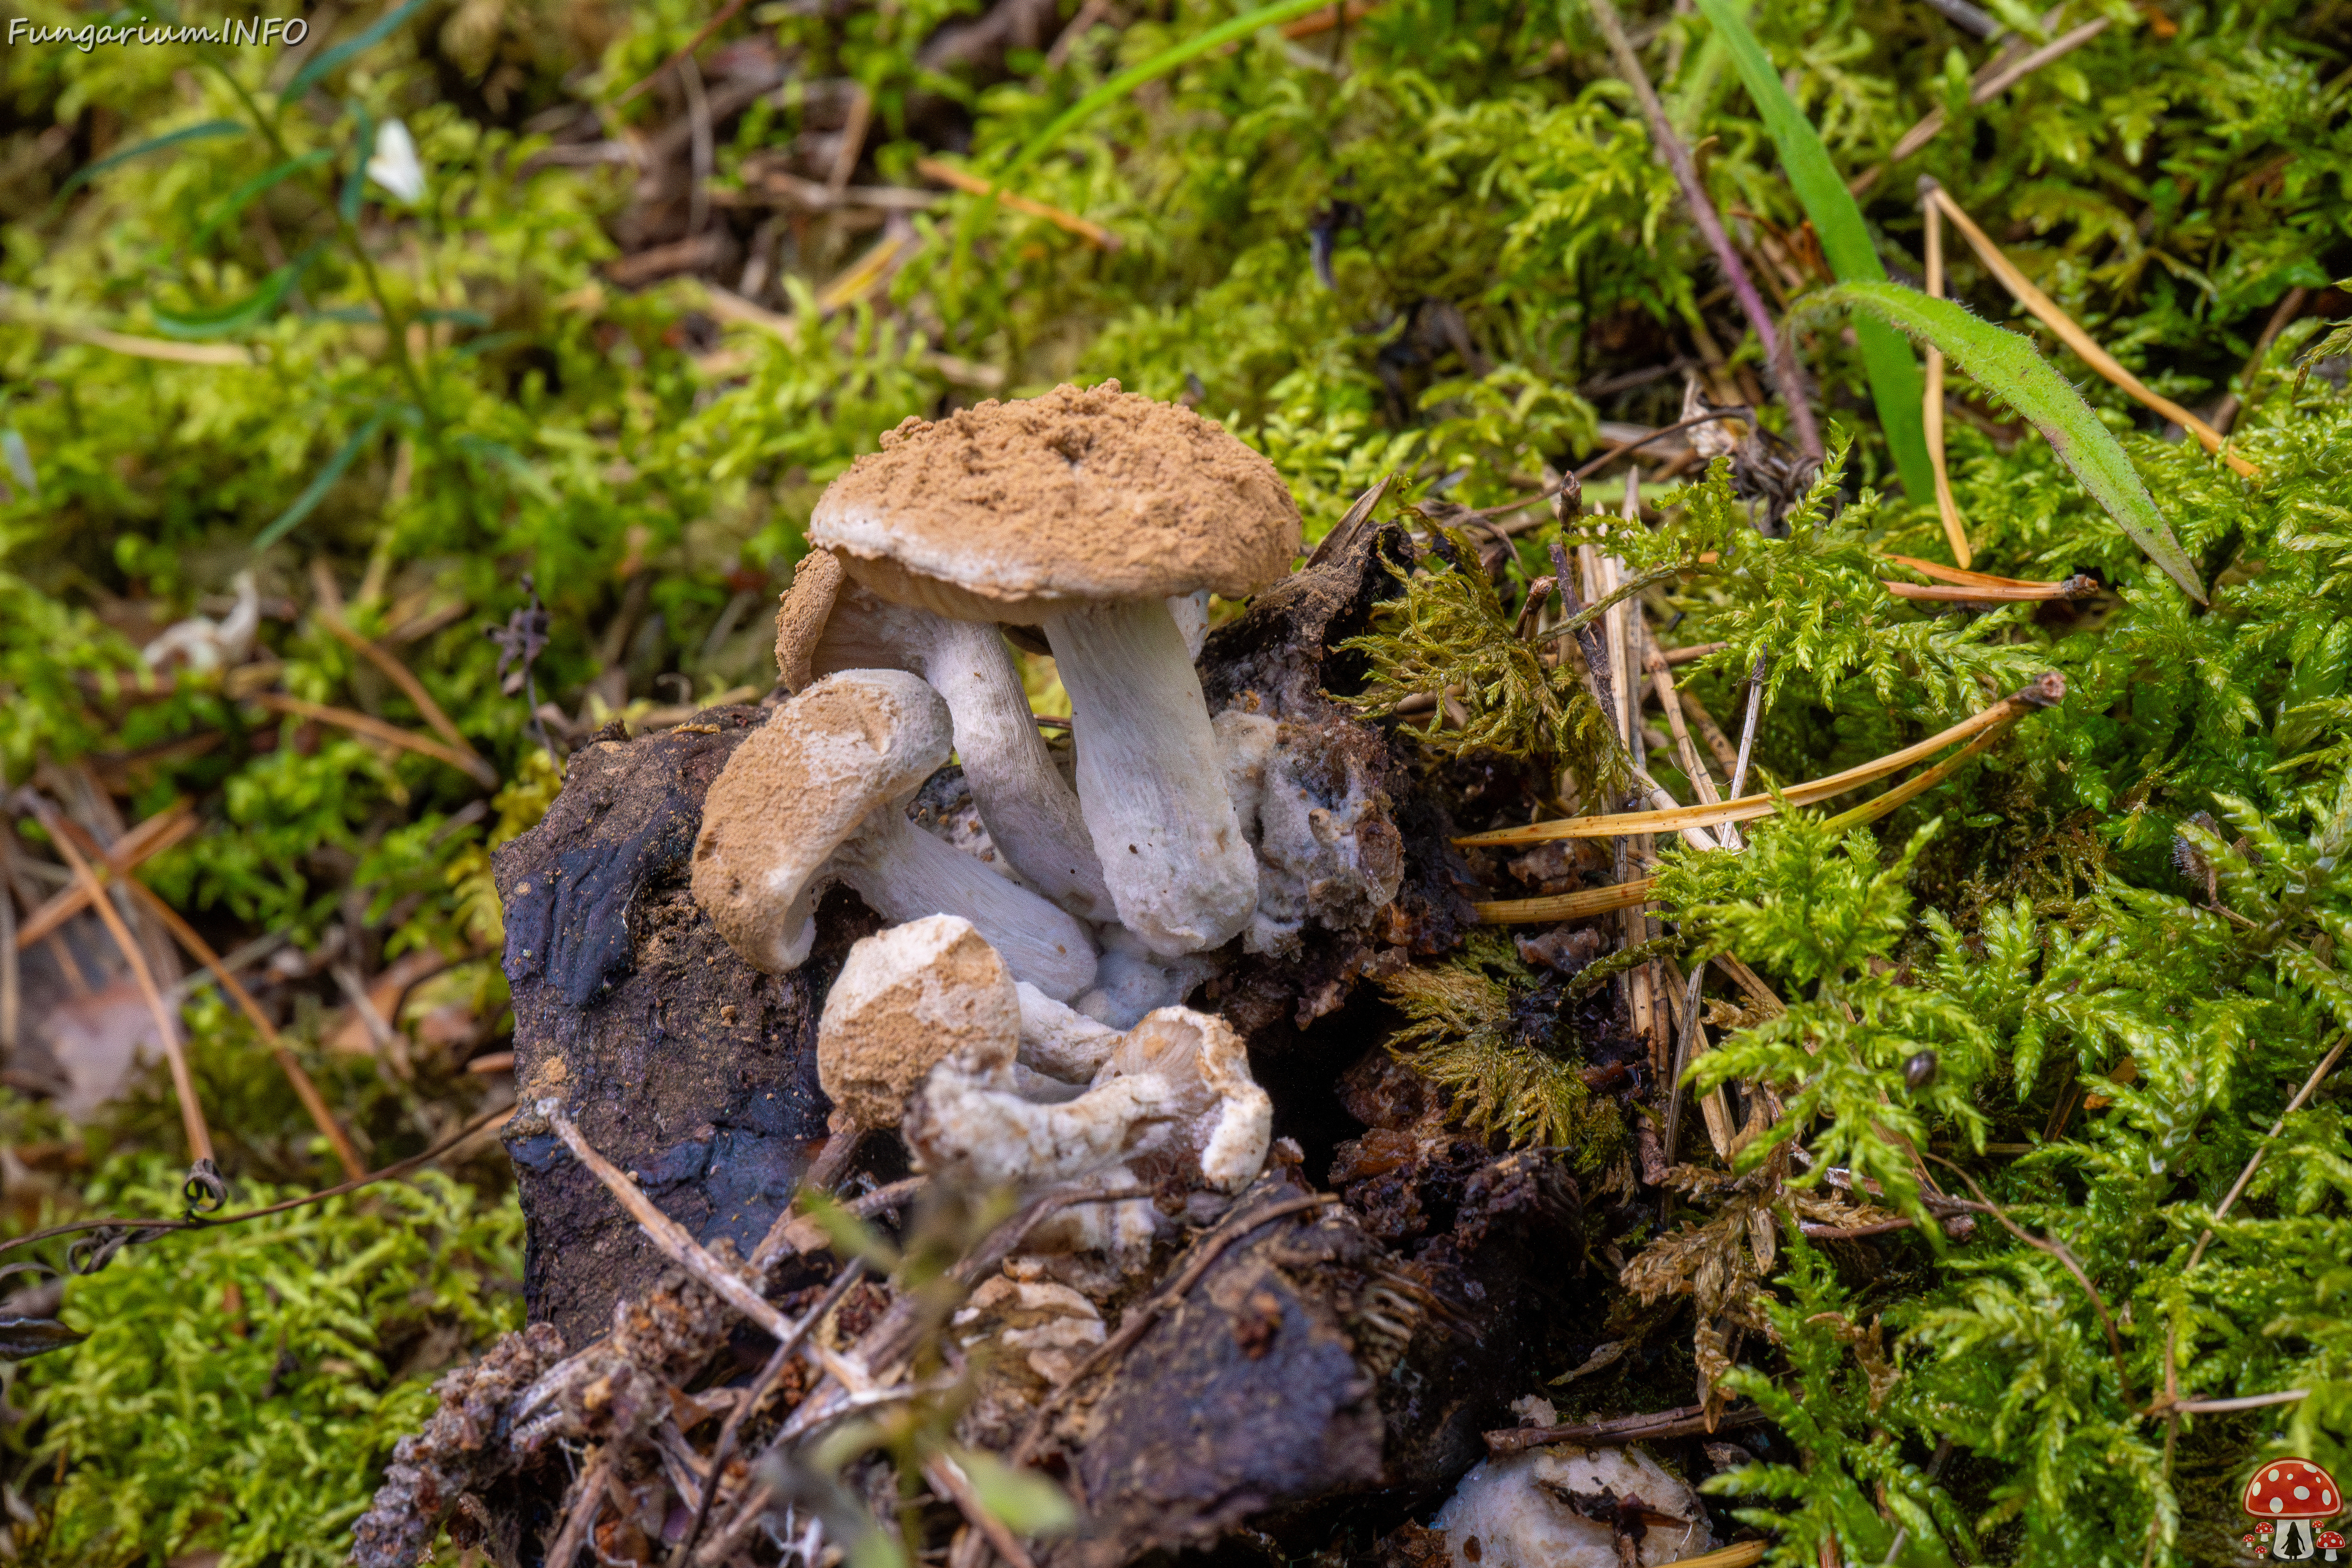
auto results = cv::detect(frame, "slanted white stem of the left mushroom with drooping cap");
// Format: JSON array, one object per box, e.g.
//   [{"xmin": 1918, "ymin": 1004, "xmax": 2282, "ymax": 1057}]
[{"xmin": 832, "ymin": 804, "xmax": 1094, "ymax": 1001}]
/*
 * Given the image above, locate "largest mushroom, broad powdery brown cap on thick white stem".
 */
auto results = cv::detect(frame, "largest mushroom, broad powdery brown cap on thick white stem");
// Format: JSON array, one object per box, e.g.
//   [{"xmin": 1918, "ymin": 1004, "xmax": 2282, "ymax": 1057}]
[{"xmin": 809, "ymin": 381, "xmax": 1298, "ymax": 957}]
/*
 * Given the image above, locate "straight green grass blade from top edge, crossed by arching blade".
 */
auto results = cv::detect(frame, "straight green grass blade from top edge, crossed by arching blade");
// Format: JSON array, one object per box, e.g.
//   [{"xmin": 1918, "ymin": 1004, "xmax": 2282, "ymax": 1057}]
[{"xmin": 1698, "ymin": 0, "xmax": 1936, "ymax": 501}]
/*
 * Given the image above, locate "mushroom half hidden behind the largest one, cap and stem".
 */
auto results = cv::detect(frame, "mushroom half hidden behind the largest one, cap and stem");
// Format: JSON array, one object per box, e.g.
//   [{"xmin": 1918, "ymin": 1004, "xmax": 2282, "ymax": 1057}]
[{"xmin": 776, "ymin": 550, "xmax": 1117, "ymax": 922}]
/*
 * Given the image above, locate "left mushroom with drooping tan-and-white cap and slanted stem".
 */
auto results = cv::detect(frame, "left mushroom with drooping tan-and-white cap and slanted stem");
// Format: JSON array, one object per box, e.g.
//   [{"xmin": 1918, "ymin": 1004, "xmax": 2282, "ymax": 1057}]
[{"xmin": 694, "ymin": 670, "xmax": 1094, "ymax": 997}]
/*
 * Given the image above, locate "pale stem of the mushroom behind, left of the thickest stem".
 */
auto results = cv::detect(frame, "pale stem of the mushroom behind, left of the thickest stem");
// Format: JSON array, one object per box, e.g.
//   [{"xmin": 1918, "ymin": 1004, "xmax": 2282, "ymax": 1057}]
[{"xmin": 918, "ymin": 611, "xmax": 1117, "ymax": 922}]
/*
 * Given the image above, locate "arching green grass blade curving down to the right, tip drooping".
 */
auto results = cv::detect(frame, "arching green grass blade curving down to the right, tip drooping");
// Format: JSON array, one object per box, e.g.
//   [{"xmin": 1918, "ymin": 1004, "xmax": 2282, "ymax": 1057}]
[{"xmin": 1814, "ymin": 282, "xmax": 2206, "ymax": 604}]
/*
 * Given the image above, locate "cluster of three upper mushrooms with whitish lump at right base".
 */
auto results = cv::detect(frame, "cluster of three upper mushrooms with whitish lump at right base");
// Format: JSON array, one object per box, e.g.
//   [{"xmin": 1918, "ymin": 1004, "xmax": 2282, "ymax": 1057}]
[{"xmin": 694, "ymin": 381, "xmax": 1397, "ymax": 1030}]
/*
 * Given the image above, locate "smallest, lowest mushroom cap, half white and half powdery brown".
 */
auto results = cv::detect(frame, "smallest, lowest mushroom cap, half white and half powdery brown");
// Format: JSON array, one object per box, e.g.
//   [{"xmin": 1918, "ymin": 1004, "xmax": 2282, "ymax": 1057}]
[{"xmin": 816, "ymin": 914, "xmax": 1021, "ymax": 1128}]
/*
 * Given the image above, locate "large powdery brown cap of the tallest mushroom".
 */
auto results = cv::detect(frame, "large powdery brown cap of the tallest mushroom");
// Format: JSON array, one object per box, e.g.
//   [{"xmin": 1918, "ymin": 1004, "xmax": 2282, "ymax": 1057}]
[{"xmin": 809, "ymin": 381, "xmax": 1298, "ymax": 623}]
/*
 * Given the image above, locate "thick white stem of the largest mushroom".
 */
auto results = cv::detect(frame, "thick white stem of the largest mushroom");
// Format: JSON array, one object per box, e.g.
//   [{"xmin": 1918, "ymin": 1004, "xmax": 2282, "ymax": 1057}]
[{"xmin": 1044, "ymin": 600, "xmax": 1258, "ymax": 957}]
